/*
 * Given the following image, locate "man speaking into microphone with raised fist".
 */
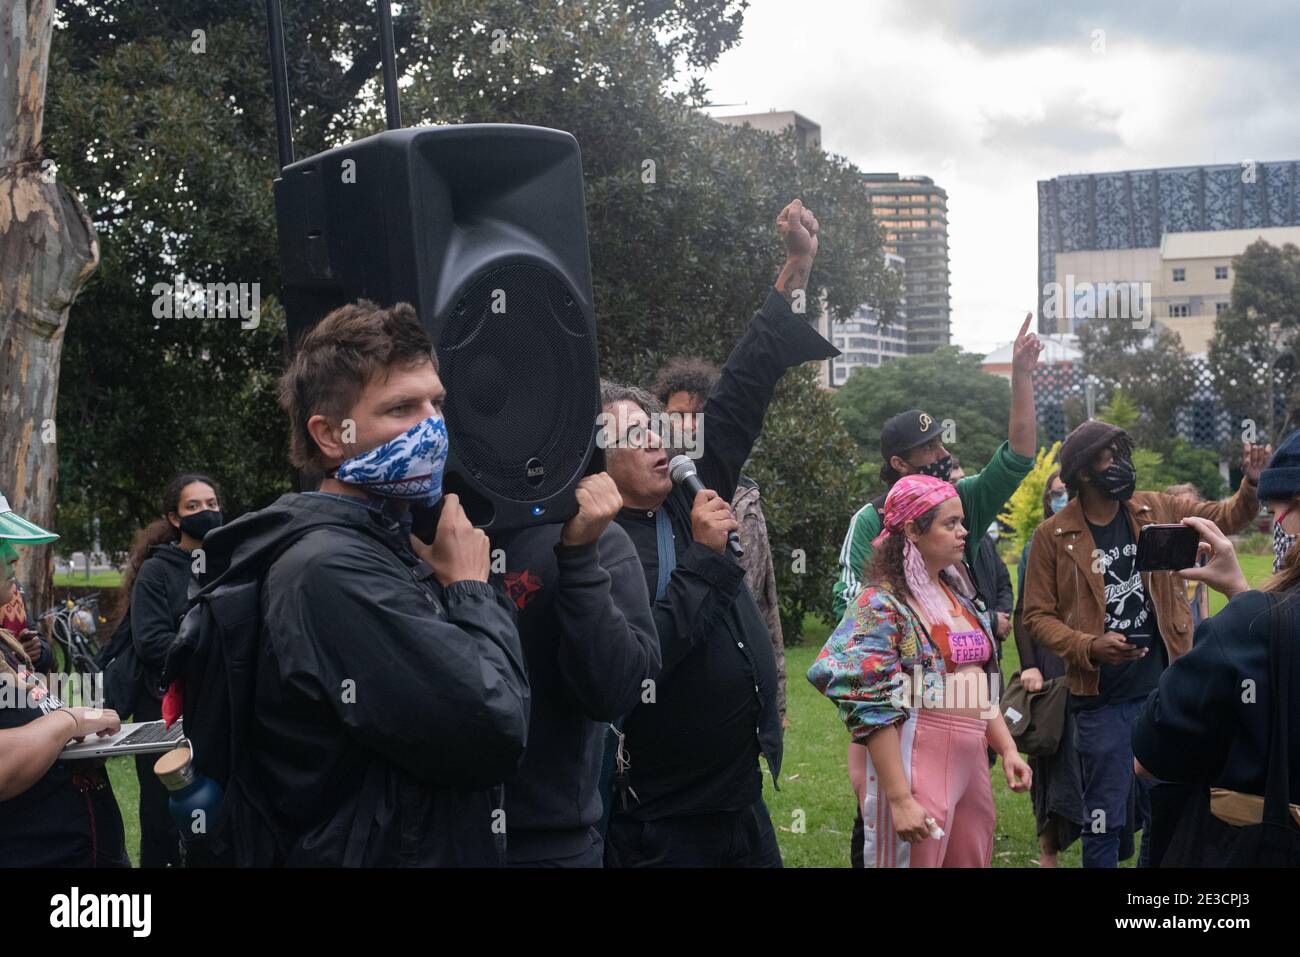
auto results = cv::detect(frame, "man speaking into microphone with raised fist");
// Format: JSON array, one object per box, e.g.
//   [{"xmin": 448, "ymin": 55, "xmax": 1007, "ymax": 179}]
[{"xmin": 601, "ymin": 200, "xmax": 839, "ymax": 867}]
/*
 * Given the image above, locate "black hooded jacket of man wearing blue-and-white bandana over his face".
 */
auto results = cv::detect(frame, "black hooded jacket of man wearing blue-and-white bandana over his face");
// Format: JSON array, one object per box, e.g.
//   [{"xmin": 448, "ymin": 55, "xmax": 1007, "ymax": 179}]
[{"xmin": 204, "ymin": 494, "xmax": 529, "ymax": 866}]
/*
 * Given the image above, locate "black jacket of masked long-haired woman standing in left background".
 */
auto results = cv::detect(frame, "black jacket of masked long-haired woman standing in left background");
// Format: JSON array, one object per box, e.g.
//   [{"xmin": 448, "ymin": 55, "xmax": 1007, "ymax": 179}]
[{"xmin": 129, "ymin": 542, "xmax": 194, "ymax": 696}]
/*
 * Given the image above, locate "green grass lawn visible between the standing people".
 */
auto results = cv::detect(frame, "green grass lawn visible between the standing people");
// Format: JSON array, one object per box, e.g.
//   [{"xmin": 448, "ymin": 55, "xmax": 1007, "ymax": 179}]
[{"xmin": 108, "ymin": 546, "xmax": 1273, "ymax": 867}]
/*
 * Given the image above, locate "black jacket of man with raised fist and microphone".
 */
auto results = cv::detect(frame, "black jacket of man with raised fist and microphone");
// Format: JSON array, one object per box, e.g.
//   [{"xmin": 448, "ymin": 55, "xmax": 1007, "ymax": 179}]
[{"xmin": 614, "ymin": 290, "xmax": 839, "ymax": 820}]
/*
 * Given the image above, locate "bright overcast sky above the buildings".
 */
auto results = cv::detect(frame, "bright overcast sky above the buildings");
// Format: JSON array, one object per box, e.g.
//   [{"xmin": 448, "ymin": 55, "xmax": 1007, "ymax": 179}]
[{"xmin": 706, "ymin": 0, "xmax": 1300, "ymax": 352}]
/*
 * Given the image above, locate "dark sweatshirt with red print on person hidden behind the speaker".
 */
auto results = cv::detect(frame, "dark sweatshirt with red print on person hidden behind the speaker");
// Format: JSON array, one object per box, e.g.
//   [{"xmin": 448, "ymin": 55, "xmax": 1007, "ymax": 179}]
[{"xmin": 493, "ymin": 523, "xmax": 659, "ymax": 863}]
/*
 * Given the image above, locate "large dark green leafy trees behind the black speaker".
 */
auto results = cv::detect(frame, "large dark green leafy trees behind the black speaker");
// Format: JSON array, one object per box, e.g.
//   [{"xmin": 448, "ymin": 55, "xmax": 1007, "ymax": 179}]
[{"xmin": 46, "ymin": 0, "xmax": 893, "ymax": 553}]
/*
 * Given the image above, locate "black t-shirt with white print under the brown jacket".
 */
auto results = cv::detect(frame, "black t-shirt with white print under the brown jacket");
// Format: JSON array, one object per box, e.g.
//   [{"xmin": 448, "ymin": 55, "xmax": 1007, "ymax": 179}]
[{"xmin": 1070, "ymin": 508, "xmax": 1169, "ymax": 710}]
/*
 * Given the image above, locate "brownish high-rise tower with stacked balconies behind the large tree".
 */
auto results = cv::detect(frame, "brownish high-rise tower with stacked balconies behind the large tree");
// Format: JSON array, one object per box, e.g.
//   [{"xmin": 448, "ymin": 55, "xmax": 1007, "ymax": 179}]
[{"xmin": 862, "ymin": 173, "xmax": 950, "ymax": 352}]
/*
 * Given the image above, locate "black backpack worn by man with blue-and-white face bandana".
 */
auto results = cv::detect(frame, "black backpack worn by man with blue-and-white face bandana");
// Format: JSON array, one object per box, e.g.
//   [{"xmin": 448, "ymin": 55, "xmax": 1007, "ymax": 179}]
[{"xmin": 163, "ymin": 529, "xmax": 309, "ymax": 867}]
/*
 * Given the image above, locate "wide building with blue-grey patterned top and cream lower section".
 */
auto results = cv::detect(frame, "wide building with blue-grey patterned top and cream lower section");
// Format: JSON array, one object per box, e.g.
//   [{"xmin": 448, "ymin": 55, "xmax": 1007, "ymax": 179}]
[{"xmin": 1037, "ymin": 160, "xmax": 1300, "ymax": 335}]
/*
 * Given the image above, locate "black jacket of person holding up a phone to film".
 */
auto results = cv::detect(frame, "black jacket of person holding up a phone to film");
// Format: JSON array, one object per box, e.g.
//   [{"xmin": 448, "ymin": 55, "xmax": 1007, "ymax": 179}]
[{"xmin": 1132, "ymin": 592, "xmax": 1300, "ymax": 802}]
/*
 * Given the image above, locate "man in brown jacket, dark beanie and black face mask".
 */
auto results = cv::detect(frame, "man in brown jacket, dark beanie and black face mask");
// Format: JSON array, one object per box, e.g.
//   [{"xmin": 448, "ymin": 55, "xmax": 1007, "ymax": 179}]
[{"xmin": 1024, "ymin": 421, "xmax": 1271, "ymax": 867}]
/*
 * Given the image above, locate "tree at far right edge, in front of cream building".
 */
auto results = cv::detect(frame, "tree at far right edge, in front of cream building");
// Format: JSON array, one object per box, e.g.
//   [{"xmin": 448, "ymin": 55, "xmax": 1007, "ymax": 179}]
[{"xmin": 1208, "ymin": 239, "xmax": 1300, "ymax": 443}]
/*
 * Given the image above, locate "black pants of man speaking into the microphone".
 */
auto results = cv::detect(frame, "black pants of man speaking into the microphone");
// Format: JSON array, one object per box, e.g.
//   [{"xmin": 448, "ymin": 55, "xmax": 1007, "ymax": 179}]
[{"xmin": 605, "ymin": 800, "xmax": 781, "ymax": 867}]
